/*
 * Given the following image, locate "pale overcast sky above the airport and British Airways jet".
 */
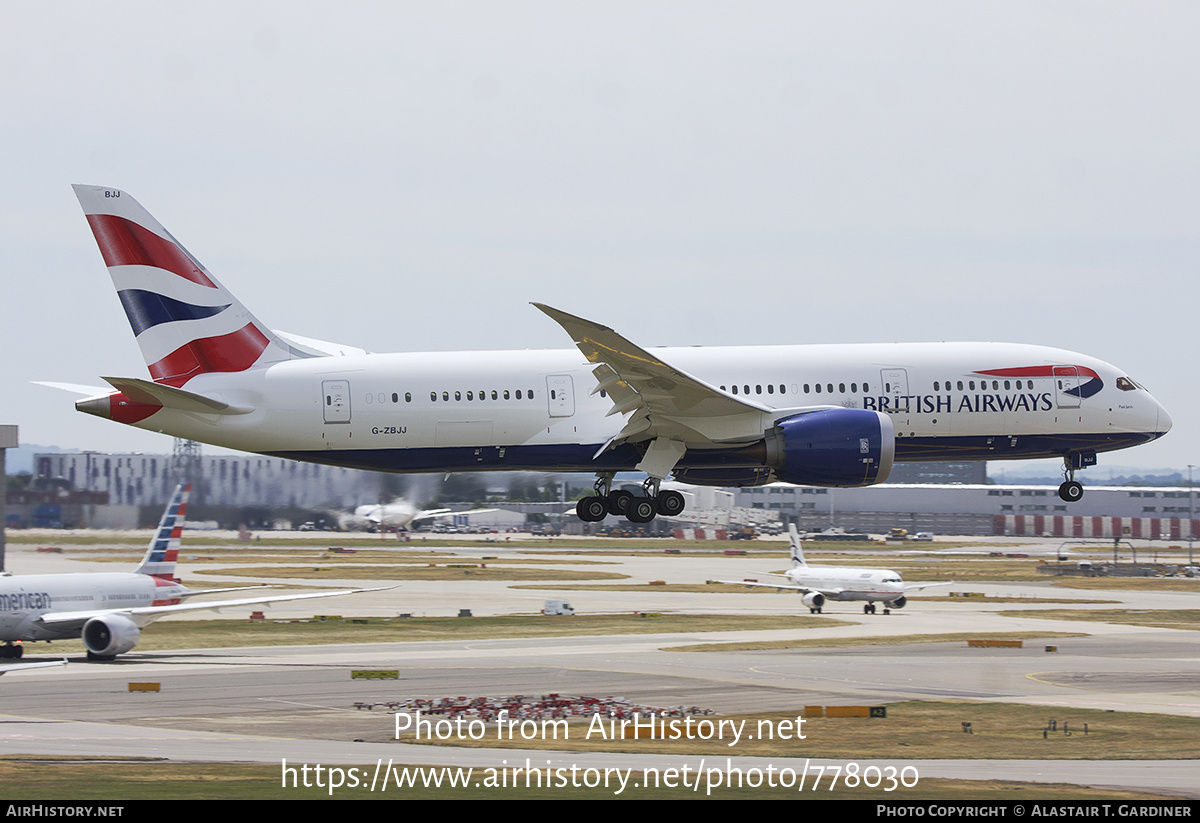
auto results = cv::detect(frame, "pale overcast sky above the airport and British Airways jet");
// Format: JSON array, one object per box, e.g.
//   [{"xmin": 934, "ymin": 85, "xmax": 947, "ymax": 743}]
[{"xmin": 0, "ymin": 0, "xmax": 1200, "ymax": 479}]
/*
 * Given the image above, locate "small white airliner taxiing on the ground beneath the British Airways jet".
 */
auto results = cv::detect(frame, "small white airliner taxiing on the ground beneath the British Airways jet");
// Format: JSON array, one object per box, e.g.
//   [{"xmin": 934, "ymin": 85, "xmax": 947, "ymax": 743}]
[{"xmin": 718, "ymin": 524, "xmax": 950, "ymax": 614}]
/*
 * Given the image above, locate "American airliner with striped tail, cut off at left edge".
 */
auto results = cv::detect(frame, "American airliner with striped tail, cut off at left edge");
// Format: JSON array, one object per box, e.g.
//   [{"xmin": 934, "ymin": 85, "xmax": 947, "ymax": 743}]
[{"xmin": 0, "ymin": 486, "xmax": 389, "ymax": 660}]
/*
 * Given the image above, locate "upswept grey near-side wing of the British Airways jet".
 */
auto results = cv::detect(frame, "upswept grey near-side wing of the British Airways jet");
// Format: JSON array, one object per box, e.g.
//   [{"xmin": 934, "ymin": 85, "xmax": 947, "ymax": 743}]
[{"xmin": 534, "ymin": 302, "xmax": 779, "ymax": 447}]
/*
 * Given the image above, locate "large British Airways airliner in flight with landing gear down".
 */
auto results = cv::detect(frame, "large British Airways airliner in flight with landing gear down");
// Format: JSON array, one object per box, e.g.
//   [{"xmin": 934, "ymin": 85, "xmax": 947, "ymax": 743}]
[{"xmin": 52, "ymin": 186, "xmax": 1171, "ymax": 522}]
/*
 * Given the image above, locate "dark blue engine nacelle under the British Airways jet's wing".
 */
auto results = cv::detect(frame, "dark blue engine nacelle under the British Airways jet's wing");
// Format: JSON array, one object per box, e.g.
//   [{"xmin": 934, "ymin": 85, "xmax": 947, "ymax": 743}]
[{"xmin": 767, "ymin": 409, "xmax": 896, "ymax": 487}]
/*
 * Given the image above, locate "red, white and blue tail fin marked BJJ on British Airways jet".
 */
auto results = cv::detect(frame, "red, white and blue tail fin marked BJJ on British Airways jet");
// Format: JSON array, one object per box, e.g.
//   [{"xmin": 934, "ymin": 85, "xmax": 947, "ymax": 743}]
[{"xmin": 74, "ymin": 186, "xmax": 311, "ymax": 389}]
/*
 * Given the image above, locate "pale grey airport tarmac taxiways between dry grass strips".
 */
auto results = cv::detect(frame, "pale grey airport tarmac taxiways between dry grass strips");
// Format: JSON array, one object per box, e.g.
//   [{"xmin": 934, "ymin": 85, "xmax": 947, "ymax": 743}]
[{"xmin": 0, "ymin": 535, "xmax": 1200, "ymax": 798}]
